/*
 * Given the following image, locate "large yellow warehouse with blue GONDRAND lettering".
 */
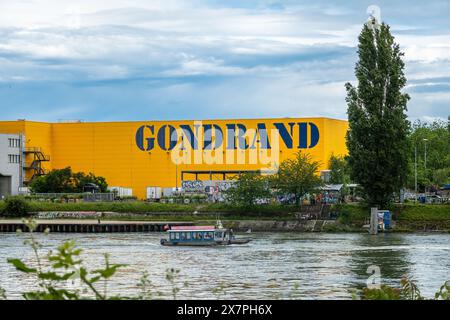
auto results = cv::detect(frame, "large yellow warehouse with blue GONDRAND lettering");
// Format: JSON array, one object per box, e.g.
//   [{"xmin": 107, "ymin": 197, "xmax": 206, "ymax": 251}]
[{"xmin": 0, "ymin": 117, "xmax": 348, "ymax": 199}]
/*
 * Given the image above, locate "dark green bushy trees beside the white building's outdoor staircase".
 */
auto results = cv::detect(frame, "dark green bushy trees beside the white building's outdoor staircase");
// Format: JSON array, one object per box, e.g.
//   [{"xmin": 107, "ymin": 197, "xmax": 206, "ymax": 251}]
[{"xmin": 30, "ymin": 167, "xmax": 108, "ymax": 193}]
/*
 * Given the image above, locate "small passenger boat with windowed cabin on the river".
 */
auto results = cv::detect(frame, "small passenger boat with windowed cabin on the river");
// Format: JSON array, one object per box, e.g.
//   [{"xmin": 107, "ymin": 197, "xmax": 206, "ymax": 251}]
[{"xmin": 161, "ymin": 224, "xmax": 252, "ymax": 246}]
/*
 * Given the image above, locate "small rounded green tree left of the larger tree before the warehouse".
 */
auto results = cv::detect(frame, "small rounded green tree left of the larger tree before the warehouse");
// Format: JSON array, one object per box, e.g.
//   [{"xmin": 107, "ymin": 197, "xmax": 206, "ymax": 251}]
[{"xmin": 226, "ymin": 172, "xmax": 270, "ymax": 207}]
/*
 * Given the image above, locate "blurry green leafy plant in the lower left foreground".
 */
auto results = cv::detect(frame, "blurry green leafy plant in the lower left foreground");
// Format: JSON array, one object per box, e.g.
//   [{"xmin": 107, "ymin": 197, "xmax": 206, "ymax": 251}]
[{"xmin": 0, "ymin": 220, "xmax": 195, "ymax": 300}]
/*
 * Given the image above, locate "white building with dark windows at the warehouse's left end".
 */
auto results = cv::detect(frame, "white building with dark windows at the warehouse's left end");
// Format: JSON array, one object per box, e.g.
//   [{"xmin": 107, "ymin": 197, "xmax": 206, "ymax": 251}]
[{"xmin": 0, "ymin": 134, "xmax": 24, "ymax": 199}]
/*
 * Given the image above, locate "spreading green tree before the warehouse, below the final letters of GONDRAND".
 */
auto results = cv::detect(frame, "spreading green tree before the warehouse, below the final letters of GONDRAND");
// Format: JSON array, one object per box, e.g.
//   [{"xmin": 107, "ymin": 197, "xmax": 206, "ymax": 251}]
[{"xmin": 272, "ymin": 151, "xmax": 323, "ymax": 205}]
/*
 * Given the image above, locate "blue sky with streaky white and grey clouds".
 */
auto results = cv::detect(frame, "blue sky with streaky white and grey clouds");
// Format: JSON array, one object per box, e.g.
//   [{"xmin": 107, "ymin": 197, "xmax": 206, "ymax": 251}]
[{"xmin": 0, "ymin": 0, "xmax": 450, "ymax": 121}]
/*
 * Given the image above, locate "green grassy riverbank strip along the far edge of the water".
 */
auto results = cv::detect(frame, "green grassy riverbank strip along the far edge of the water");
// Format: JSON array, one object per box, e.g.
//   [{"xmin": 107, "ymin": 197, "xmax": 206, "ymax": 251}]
[{"xmin": 0, "ymin": 201, "xmax": 450, "ymax": 232}]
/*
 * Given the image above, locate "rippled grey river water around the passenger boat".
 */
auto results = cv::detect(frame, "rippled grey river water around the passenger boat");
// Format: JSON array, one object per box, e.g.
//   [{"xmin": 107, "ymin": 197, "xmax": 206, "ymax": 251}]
[{"xmin": 0, "ymin": 233, "xmax": 450, "ymax": 299}]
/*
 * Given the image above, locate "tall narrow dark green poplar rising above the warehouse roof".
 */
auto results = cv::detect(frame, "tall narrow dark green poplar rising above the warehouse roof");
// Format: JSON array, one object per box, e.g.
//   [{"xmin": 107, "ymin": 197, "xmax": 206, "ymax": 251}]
[{"xmin": 346, "ymin": 19, "xmax": 410, "ymax": 206}]
